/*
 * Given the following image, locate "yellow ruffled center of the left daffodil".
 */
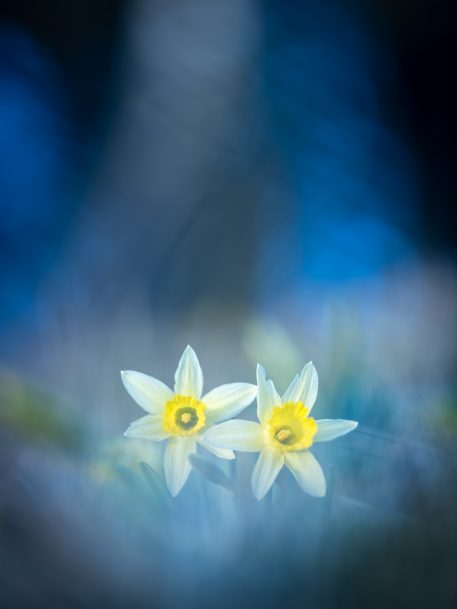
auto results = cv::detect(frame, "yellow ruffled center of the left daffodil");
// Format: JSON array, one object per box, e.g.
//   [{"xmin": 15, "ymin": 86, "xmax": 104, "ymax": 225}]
[{"xmin": 162, "ymin": 395, "xmax": 206, "ymax": 436}]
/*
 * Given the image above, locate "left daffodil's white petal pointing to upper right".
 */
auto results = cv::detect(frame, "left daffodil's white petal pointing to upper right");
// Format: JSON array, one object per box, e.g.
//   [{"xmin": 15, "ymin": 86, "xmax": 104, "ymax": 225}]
[{"xmin": 202, "ymin": 383, "xmax": 257, "ymax": 422}]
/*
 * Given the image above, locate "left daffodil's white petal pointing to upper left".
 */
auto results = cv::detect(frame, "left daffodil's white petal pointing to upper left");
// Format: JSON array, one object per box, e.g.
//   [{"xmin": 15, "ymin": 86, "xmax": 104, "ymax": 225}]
[{"xmin": 121, "ymin": 370, "xmax": 173, "ymax": 414}]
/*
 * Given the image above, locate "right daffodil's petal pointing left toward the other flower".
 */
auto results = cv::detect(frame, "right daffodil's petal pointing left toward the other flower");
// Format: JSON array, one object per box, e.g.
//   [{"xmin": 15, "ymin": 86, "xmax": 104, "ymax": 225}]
[{"xmin": 203, "ymin": 419, "xmax": 265, "ymax": 452}]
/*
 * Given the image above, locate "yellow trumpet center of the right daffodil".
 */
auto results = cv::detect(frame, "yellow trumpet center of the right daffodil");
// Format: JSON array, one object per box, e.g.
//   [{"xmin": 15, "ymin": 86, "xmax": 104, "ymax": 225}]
[{"xmin": 266, "ymin": 402, "xmax": 317, "ymax": 452}]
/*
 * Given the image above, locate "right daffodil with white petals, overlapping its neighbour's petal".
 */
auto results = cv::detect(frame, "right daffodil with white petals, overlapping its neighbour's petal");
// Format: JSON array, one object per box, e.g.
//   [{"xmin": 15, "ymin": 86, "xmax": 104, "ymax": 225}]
[{"xmin": 203, "ymin": 362, "xmax": 358, "ymax": 500}]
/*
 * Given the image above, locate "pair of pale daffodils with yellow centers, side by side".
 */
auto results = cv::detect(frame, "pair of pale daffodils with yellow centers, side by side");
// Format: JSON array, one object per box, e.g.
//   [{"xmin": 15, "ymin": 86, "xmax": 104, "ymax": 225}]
[{"xmin": 121, "ymin": 346, "xmax": 357, "ymax": 500}]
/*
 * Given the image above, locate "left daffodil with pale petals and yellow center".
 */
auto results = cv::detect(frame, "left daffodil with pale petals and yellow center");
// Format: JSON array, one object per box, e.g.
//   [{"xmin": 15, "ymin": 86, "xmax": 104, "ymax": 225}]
[{"xmin": 121, "ymin": 346, "xmax": 257, "ymax": 497}]
